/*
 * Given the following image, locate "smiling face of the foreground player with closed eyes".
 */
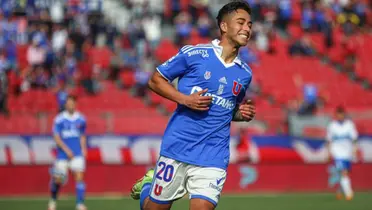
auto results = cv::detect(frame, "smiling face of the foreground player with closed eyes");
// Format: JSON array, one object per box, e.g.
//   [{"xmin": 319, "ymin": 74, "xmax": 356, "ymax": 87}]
[{"xmin": 226, "ymin": 9, "xmax": 252, "ymax": 47}]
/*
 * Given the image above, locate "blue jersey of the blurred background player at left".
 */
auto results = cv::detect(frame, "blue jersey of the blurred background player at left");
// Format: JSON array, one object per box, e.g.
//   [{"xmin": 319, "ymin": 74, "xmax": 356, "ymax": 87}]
[{"xmin": 53, "ymin": 111, "xmax": 86, "ymax": 159}]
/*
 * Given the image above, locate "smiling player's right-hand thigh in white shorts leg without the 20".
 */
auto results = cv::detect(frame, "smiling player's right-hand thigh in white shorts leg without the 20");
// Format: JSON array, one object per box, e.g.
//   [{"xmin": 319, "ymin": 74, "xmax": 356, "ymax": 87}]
[{"xmin": 186, "ymin": 166, "xmax": 227, "ymax": 210}]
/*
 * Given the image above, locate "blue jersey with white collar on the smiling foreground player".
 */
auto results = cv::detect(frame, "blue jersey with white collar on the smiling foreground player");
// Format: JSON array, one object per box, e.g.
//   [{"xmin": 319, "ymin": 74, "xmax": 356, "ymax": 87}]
[{"xmin": 157, "ymin": 40, "xmax": 252, "ymax": 169}]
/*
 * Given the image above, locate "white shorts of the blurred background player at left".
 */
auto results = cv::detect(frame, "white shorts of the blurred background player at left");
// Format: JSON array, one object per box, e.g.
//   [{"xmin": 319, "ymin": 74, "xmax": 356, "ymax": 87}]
[{"xmin": 51, "ymin": 157, "xmax": 85, "ymax": 183}]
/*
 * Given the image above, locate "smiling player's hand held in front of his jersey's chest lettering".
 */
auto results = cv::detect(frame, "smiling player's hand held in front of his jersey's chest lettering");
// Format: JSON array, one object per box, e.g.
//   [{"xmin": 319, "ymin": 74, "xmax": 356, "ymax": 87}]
[{"xmin": 183, "ymin": 89, "xmax": 212, "ymax": 111}]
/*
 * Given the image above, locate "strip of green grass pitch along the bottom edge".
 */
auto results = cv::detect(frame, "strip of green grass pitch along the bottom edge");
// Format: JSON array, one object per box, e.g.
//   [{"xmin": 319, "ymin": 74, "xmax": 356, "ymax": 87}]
[{"xmin": 0, "ymin": 192, "xmax": 372, "ymax": 210}]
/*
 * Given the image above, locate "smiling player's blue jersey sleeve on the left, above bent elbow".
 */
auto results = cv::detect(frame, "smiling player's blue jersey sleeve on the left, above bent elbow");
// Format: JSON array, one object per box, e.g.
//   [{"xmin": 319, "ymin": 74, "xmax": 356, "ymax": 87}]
[{"xmin": 157, "ymin": 51, "xmax": 188, "ymax": 82}]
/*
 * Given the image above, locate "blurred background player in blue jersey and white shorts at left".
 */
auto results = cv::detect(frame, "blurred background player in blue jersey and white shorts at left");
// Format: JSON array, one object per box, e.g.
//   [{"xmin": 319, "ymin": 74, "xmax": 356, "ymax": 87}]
[{"xmin": 48, "ymin": 96, "xmax": 87, "ymax": 210}]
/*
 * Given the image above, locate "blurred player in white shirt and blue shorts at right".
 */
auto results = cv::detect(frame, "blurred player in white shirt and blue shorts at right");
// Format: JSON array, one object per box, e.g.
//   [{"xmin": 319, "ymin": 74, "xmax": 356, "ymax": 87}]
[{"xmin": 326, "ymin": 107, "xmax": 358, "ymax": 200}]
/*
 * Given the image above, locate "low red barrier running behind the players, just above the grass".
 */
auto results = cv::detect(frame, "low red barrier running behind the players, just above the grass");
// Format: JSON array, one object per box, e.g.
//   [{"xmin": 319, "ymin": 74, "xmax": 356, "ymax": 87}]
[{"xmin": 0, "ymin": 164, "xmax": 372, "ymax": 196}]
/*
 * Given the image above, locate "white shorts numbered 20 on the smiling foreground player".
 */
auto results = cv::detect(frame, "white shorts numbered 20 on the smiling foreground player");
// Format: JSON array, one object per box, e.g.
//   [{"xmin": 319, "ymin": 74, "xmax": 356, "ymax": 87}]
[{"xmin": 150, "ymin": 157, "xmax": 227, "ymax": 206}]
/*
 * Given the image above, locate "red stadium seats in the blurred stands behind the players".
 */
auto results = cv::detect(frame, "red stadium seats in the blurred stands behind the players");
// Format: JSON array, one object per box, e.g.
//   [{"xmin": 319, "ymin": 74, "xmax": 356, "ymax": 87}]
[{"xmin": 0, "ymin": 0, "xmax": 372, "ymax": 134}]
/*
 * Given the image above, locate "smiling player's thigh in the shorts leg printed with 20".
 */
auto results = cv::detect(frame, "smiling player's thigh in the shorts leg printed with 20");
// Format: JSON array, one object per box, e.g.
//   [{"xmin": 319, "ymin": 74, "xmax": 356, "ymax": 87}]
[{"xmin": 150, "ymin": 157, "xmax": 187, "ymax": 205}]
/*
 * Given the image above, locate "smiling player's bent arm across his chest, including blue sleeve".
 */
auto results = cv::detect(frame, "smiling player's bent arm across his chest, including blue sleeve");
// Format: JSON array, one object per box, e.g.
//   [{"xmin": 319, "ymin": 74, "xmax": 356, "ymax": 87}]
[{"xmin": 148, "ymin": 52, "xmax": 212, "ymax": 111}]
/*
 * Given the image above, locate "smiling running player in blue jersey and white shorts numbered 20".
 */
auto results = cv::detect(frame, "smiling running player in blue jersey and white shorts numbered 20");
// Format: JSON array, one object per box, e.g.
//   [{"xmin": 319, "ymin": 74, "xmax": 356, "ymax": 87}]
[{"xmin": 131, "ymin": 1, "xmax": 255, "ymax": 210}]
